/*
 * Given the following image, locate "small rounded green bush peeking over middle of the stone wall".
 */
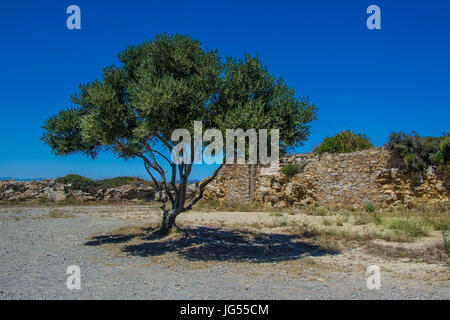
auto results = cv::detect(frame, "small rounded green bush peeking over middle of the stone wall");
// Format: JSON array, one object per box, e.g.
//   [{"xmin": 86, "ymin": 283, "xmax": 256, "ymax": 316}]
[{"xmin": 314, "ymin": 130, "xmax": 373, "ymax": 153}]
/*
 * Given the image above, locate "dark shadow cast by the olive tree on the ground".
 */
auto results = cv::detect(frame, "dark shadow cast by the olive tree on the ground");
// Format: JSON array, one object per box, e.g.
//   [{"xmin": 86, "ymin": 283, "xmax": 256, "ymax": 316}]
[{"xmin": 86, "ymin": 227, "xmax": 339, "ymax": 262}]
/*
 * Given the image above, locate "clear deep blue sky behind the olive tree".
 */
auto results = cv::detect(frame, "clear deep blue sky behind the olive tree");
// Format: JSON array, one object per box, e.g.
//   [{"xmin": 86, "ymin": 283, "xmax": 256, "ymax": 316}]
[{"xmin": 0, "ymin": 0, "xmax": 450, "ymax": 179}]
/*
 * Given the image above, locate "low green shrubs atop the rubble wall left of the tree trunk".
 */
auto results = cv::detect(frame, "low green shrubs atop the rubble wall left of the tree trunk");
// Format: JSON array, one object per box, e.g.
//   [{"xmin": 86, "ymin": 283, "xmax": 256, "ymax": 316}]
[{"xmin": 55, "ymin": 174, "xmax": 151, "ymax": 192}]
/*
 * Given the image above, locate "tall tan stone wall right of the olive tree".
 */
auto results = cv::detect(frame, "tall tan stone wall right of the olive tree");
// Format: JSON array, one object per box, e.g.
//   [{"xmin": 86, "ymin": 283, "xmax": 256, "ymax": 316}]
[{"xmin": 205, "ymin": 148, "xmax": 450, "ymax": 207}]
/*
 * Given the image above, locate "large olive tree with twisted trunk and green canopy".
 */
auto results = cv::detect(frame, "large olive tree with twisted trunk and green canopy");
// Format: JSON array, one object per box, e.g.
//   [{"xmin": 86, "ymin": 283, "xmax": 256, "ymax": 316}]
[{"xmin": 42, "ymin": 34, "xmax": 315, "ymax": 235}]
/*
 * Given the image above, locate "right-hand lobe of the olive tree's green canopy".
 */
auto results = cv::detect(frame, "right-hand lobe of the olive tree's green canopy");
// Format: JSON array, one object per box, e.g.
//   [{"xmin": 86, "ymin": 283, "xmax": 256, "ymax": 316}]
[{"xmin": 211, "ymin": 55, "xmax": 316, "ymax": 152}]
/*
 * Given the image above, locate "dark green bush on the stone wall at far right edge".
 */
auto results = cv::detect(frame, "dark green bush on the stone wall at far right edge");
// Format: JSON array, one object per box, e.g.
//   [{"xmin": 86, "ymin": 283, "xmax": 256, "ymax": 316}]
[{"xmin": 386, "ymin": 132, "xmax": 450, "ymax": 171}]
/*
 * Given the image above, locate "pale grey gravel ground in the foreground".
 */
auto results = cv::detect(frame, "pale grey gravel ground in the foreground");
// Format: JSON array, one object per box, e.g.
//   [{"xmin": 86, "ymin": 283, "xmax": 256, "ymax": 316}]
[{"xmin": 0, "ymin": 207, "xmax": 450, "ymax": 299}]
